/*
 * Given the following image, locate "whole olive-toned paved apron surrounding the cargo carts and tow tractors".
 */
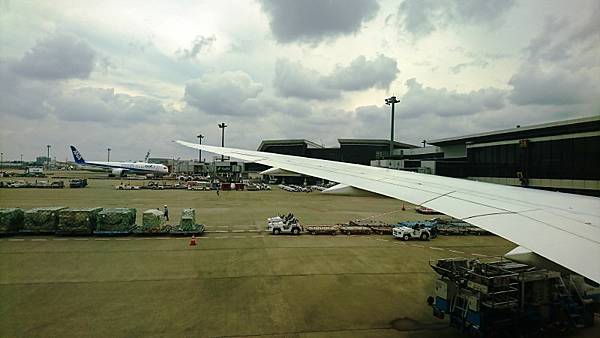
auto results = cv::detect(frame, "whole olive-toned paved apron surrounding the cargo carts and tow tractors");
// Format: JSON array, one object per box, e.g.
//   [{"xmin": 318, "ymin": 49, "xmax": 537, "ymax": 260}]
[{"xmin": 0, "ymin": 173, "xmax": 599, "ymax": 337}]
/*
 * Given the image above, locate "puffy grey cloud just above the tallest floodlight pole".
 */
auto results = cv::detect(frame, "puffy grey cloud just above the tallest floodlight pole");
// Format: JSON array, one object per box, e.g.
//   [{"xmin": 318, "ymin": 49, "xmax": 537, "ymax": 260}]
[{"xmin": 323, "ymin": 55, "xmax": 400, "ymax": 90}]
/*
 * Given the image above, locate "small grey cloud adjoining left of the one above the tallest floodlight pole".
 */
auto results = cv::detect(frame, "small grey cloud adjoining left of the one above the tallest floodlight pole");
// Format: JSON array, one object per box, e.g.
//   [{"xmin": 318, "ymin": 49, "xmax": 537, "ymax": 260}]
[{"xmin": 273, "ymin": 59, "xmax": 340, "ymax": 100}]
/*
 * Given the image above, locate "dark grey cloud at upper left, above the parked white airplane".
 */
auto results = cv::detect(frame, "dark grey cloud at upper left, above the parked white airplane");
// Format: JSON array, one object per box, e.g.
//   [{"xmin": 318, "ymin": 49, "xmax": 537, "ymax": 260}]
[{"xmin": 14, "ymin": 34, "xmax": 96, "ymax": 80}]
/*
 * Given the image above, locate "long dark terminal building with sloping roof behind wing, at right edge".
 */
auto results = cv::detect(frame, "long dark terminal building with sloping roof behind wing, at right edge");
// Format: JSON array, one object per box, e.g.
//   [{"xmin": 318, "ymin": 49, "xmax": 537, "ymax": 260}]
[{"xmin": 371, "ymin": 115, "xmax": 600, "ymax": 196}]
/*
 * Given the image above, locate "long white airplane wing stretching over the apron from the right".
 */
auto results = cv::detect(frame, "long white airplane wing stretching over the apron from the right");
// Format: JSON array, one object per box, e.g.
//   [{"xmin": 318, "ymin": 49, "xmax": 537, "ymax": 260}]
[{"xmin": 176, "ymin": 141, "xmax": 600, "ymax": 283}]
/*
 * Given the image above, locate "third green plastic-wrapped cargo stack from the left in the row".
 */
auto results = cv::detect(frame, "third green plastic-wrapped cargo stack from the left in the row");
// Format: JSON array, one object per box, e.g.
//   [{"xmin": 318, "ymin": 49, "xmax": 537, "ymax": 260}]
[{"xmin": 56, "ymin": 208, "xmax": 102, "ymax": 235}]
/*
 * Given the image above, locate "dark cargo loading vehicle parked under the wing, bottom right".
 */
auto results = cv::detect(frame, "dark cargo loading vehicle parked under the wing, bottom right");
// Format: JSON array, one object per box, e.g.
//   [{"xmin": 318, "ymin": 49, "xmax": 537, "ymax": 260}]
[{"xmin": 427, "ymin": 257, "xmax": 595, "ymax": 337}]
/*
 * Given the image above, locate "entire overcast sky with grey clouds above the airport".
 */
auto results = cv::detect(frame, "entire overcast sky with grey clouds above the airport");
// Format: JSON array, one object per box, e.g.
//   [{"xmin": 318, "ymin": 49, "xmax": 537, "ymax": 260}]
[{"xmin": 0, "ymin": 0, "xmax": 600, "ymax": 160}]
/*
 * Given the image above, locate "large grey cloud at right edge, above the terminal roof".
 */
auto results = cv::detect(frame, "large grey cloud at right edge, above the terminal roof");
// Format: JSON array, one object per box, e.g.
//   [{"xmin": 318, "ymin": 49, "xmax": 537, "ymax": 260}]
[{"xmin": 508, "ymin": 4, "xmax": 600, "ymax": 107}]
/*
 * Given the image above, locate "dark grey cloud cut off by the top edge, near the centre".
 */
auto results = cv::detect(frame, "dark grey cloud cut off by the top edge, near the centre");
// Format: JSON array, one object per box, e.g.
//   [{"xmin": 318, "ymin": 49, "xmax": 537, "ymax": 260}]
[{"xmin": 261, "ymin": 0, "xmax": 379, "ymax": 43}]
